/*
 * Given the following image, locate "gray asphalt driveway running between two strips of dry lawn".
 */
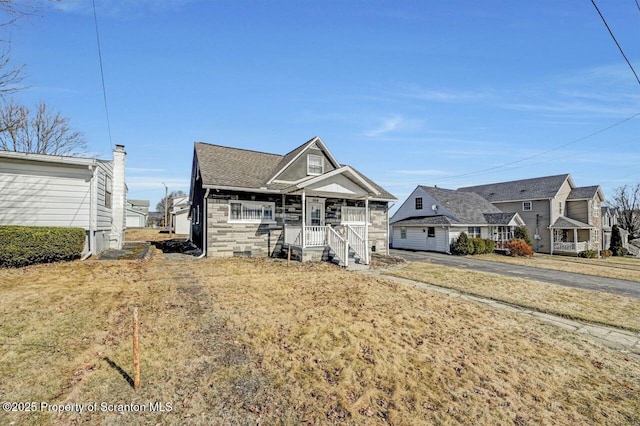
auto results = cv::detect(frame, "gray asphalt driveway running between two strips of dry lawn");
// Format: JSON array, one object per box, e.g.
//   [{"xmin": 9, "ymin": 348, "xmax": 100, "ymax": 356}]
[{"xmin": 390, "ymin": 249, "xmax": 640, "ymax": 299}]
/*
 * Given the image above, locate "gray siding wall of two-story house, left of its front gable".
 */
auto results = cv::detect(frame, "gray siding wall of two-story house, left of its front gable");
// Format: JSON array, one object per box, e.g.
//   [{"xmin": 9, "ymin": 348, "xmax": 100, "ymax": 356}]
[{"xmin": 493, "ymin": 200, "xmax": 557, "ymax": 253}]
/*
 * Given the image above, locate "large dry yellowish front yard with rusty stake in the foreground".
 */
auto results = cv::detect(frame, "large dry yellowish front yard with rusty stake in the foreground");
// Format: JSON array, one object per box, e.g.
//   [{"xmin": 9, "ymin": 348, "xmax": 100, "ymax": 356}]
[{"xmin": 0, "ymin": 251, "xmax": 640, "ymax": 425}]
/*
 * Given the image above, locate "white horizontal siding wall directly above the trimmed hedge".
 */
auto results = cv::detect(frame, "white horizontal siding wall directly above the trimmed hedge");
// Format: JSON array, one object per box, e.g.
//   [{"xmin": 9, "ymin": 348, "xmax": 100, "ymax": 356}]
[{"xmin": 0, "ymin": 159, "xmax": 91, "ymax": 230}]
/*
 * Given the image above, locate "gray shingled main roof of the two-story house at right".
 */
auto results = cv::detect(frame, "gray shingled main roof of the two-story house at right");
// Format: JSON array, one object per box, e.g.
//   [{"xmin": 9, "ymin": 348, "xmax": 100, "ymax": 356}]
[{"xmin": 458, "ymin": 174, "xmax": 573, "ymax": 203}]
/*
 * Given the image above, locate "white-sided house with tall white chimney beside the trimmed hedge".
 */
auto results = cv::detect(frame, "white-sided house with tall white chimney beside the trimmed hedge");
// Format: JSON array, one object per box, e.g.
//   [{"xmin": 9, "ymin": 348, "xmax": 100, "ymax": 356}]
[{"xmin": 0, "ymin": 145, "xmax": 126, "ymax": 254}]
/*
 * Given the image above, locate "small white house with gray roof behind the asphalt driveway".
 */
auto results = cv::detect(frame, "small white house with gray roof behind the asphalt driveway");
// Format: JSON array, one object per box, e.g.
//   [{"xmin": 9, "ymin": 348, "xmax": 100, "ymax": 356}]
[{"xmin": 390, "ymin": 186, "xmax": 524, "ymax": 253}]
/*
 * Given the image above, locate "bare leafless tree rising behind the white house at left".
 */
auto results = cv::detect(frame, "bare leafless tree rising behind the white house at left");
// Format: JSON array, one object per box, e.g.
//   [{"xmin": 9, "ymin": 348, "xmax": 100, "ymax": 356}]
[{"xmin": 0, "ymin": 100, "xmax": 87, "ymax": 155}]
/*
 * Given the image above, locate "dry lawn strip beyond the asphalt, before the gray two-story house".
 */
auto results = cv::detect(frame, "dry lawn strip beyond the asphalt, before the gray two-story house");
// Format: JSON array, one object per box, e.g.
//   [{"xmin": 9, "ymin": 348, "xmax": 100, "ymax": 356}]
[{"xmin": 473, "ymin": 253, "xmax": 640, "ymax": 282}]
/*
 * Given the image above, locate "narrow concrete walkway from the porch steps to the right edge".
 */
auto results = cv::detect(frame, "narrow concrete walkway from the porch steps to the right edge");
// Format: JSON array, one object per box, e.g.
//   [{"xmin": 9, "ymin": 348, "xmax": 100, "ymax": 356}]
[{"xmin": 358, "ymin": 269, "xmax": 640, "ymax": 359}]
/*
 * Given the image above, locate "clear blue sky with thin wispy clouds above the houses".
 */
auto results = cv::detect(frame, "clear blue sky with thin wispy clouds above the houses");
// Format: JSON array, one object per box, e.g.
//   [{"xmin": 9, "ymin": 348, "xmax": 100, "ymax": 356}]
[{"xmin": 10, "ymin": 0, "xmax": 640, "ymax": 211}]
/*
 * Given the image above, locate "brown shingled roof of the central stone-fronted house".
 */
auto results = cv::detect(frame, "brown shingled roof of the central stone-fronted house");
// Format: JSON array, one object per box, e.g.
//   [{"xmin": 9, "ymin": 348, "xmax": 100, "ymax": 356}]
[{"xmin": 195, "ymin": 138, "xmax": 396, "ymax": 201}]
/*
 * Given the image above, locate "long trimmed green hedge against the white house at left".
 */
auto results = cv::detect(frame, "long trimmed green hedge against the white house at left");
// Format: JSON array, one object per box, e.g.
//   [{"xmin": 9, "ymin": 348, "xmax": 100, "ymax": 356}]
[{"xmin": 0, "ymin": 226, "xmax": 86, "ymax": 268}]
